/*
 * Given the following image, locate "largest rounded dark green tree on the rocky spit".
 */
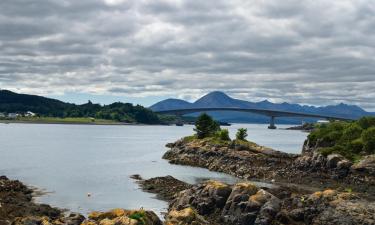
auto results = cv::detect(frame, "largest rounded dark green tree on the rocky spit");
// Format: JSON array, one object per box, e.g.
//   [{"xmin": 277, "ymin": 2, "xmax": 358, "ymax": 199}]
[{"xmin": 194, "ymin": 113, "xmax": 220, "ymax": 139}]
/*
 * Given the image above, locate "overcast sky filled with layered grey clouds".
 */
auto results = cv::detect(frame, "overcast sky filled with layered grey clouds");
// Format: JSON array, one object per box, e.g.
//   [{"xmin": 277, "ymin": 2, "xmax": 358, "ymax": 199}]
[{"xmin": 0, "ymin": 0, "xmax": 375, "ymax": 111}]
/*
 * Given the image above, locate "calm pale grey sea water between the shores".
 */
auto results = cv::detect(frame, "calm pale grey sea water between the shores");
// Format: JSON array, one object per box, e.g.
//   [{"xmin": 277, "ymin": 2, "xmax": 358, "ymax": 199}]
[{"xmin": 0, "ymin": 124, "xmax": 306, "ymax": 214}]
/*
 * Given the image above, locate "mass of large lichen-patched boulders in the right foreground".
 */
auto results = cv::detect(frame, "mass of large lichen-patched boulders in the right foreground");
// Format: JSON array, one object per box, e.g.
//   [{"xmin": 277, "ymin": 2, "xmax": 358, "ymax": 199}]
[{"xmin": 167, "ymin": 181, "xmax": 375, "ymax": 225}]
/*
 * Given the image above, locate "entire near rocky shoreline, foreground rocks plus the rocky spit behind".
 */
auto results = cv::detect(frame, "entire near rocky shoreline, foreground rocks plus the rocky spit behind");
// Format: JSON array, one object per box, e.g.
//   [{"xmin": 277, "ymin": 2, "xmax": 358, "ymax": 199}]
[{"xmin": 0, "ymin": 134, "xmax": 375, "ymax": 225}]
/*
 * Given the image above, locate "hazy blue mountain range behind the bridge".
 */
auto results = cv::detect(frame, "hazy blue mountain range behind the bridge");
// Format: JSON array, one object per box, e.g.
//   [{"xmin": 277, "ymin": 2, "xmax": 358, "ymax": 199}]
[{"xmin": 150, "ymin": 91, "xmax": 375, "ymax": 123}]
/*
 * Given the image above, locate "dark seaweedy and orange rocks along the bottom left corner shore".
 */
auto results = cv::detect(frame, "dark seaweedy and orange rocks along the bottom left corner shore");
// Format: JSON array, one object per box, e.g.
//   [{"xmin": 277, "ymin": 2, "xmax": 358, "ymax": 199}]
[{"xmin": 0, "ymin": 176, "xmax": 163, "ymax": 225}]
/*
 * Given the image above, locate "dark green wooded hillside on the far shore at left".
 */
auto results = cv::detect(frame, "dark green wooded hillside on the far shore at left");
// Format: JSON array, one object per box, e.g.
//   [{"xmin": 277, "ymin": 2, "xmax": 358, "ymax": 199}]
[{"xmin": 0, "ymin": 90, "xmax": 167, "ymax": 124}]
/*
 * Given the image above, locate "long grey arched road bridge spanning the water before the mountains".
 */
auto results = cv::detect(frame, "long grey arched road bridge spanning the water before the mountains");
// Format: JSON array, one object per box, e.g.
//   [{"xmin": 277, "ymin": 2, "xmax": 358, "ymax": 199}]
[{"xmin": 154, "ymin": 107, "xmax": 353, "ymax": 129}]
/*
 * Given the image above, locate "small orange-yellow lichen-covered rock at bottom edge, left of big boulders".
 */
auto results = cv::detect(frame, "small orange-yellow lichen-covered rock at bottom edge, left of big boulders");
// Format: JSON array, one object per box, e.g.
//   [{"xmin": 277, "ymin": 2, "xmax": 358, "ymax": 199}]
[{"xmin": 165, "ymin": 207, "xmax": 210, "ymax": 225}]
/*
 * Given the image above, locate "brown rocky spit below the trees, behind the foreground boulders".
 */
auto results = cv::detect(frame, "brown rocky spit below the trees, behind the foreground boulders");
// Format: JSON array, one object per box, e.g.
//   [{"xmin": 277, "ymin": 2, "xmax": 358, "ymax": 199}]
[{"xmin": 163, "ymin": 139, "xmax": 375, "ymax": 196}]
